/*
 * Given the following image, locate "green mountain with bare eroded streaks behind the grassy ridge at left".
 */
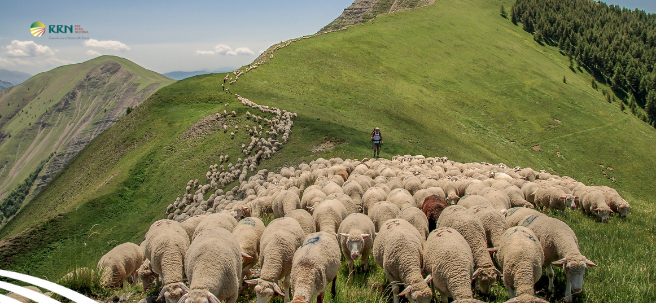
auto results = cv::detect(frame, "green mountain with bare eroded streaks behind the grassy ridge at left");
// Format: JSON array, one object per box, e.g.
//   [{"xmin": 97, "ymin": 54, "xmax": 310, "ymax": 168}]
[{"xmin": 0, "ymin": 56, "xmax": 174, "ymax": 220}]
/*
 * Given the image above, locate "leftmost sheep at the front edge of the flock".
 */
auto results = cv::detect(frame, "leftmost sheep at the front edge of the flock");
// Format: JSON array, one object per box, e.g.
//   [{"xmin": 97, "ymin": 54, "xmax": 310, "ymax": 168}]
[{"xmin": 98, "ymin": 242, "xmax": 145, "ymax": 287}]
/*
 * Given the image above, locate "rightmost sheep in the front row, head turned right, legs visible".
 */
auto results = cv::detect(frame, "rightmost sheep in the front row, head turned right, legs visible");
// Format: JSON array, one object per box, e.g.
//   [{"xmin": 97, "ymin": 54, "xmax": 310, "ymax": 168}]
[{"xmin": 519, "ymin": 215, "xmax": 597, "ymax": 302}]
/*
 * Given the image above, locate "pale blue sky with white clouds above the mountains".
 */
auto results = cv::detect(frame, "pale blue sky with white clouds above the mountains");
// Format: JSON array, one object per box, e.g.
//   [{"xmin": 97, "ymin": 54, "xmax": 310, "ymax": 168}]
[{"xmin": 0, "ymin": 0, "xmax": 656, "ymax": 74}]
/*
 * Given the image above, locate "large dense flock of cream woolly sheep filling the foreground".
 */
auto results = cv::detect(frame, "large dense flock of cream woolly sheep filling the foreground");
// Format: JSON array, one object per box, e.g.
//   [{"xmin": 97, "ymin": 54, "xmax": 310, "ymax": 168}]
[{"xmin": 88, "ymin": 156, "xmax": 629, "ymax": 303}]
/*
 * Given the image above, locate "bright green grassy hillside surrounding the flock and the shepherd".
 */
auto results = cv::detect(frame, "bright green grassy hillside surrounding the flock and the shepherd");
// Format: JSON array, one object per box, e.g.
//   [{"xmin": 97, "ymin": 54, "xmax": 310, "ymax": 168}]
[{"xmin": 0, "ymin": 0, "xmax": 656, "ymax": 302}]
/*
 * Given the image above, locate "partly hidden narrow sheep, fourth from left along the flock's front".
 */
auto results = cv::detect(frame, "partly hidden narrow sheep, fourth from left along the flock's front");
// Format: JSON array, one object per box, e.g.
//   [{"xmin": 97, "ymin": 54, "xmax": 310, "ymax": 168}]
[{"xmin": 232, "ymin": 217, "xmax": 264, "ymax": 285}]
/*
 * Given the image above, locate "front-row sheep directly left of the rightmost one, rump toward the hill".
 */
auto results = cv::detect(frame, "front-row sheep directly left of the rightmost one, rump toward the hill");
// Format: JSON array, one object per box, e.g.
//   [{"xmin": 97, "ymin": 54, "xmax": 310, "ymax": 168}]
[{"xmin": 496, "ymin": 226, "xmax": 547, "ymax": 303}]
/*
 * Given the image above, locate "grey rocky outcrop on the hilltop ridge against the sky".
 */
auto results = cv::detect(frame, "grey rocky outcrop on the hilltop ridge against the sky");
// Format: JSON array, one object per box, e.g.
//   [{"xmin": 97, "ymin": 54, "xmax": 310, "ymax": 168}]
[{"xmin": 319, "ymin": 0, "xmax": 435, "ymax": 32}]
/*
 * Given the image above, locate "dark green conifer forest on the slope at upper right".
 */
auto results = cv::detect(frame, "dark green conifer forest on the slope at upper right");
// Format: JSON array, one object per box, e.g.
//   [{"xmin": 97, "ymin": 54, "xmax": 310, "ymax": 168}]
[{"xmin": 510, "ymin": 0, "xmax": 656, "ymax": 127}]
